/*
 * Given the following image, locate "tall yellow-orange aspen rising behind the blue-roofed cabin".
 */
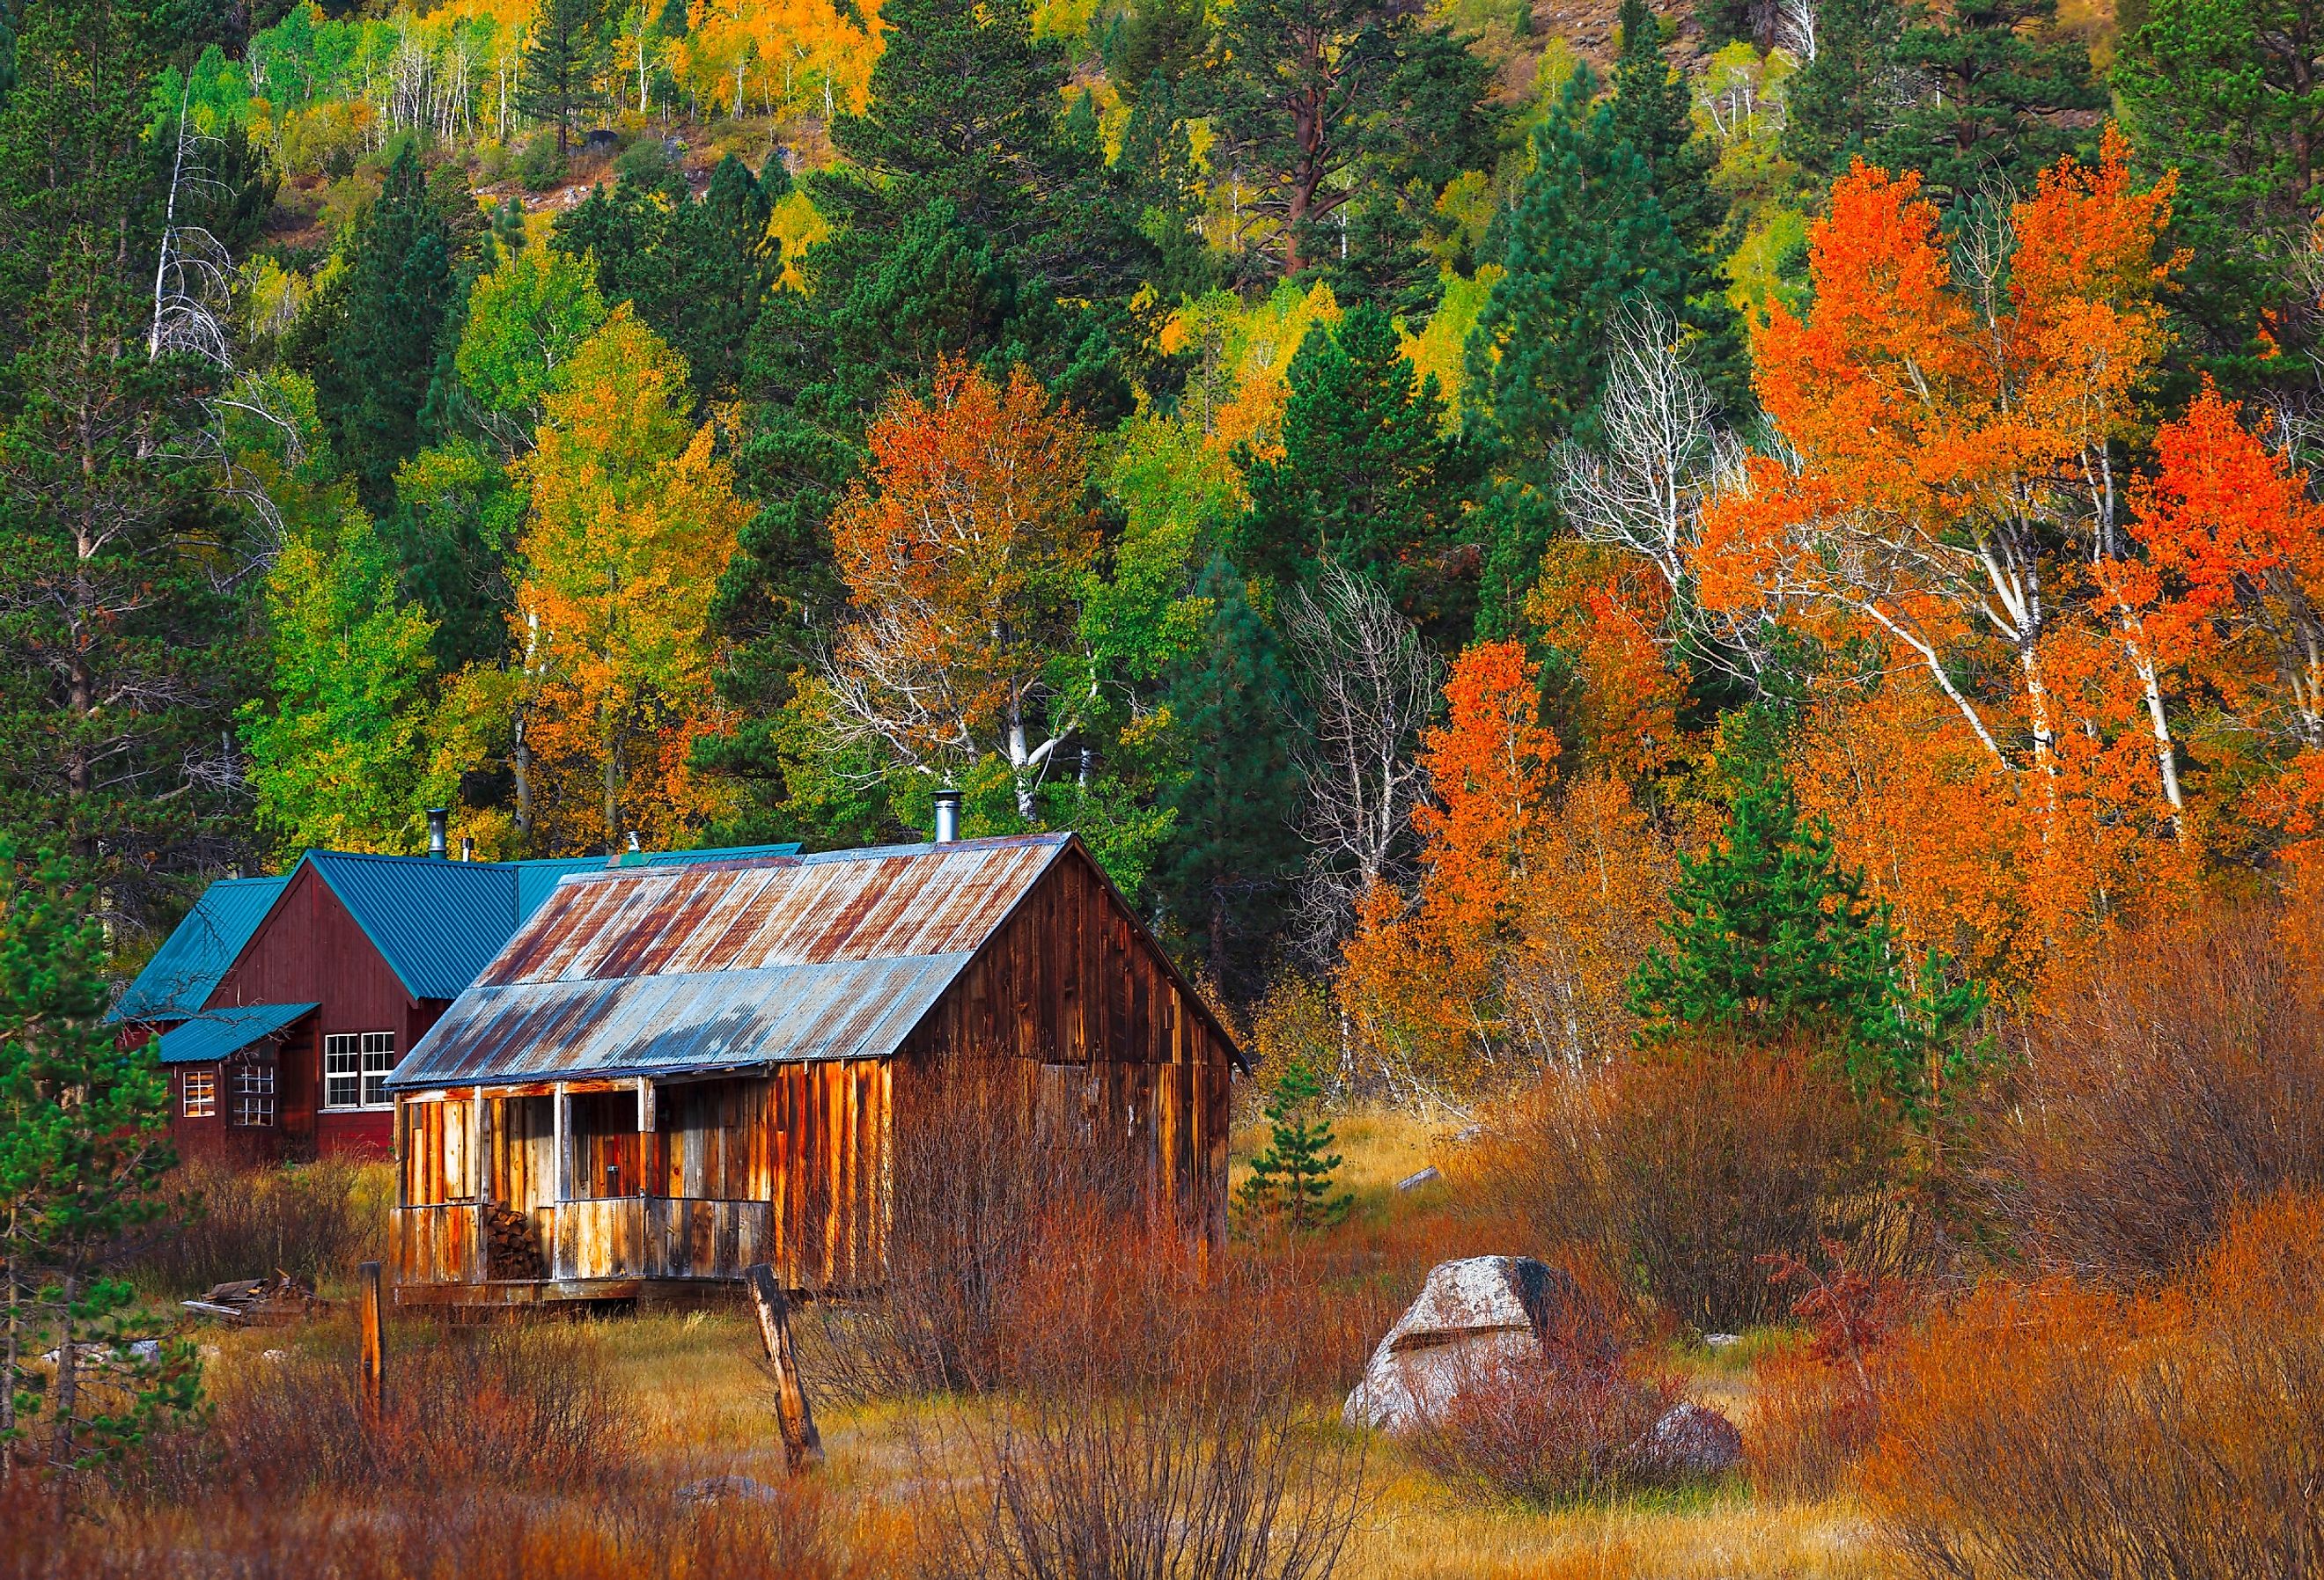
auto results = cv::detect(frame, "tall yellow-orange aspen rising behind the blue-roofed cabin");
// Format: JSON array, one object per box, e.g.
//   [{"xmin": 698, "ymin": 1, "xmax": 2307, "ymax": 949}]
[{"xmin": 509, "ymin": 305, "xmax": 748, "ymax": 850}]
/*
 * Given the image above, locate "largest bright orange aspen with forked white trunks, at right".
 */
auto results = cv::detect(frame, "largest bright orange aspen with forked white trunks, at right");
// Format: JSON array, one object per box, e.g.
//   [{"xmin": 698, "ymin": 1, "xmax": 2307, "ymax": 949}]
[{"xmin": 1696, "ymin": 137, "xmax": 2180, "ymax": 820}]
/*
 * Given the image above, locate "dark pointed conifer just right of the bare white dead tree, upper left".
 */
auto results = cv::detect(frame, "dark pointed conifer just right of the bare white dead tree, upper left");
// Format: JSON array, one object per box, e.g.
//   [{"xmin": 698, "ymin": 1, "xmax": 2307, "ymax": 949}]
[{"xmin": 283, "ymin": 142, "xmax": 474, "ymax": 513}]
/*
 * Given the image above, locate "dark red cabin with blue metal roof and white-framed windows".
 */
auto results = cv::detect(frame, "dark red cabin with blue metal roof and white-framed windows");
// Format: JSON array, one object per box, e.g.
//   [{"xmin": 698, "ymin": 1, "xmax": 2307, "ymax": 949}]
[{"xmin": 114, "ymin": 846, "xmax": 798, "ymax": 1164}]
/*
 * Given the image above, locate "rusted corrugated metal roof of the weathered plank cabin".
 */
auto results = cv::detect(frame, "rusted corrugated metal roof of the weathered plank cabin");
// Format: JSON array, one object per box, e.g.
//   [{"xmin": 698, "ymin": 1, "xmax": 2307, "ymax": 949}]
[{"xmin": 388, "ymin": 834, "xmax": 1071, "ymax": 1090}]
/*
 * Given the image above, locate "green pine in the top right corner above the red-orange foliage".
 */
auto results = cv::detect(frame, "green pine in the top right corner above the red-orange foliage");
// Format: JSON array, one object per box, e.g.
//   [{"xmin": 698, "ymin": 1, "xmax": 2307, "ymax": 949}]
[{"xmin": 2113, "ymin": 0, "xmax": 2324, "ymax": 404}]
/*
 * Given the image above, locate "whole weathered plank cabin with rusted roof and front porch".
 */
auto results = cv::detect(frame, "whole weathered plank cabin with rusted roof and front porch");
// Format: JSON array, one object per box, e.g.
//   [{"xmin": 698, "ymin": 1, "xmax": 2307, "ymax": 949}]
[{"xmin": 388, "ymin": 834, "xmax": 1241, "ymax": 1304}]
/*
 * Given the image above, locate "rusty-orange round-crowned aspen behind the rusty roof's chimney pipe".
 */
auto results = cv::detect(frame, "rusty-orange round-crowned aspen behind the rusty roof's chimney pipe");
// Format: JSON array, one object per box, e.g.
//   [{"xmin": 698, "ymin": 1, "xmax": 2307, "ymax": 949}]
[{"xmin": 825, "ymin": 363, "xmax": 1099, "ymax": 818}]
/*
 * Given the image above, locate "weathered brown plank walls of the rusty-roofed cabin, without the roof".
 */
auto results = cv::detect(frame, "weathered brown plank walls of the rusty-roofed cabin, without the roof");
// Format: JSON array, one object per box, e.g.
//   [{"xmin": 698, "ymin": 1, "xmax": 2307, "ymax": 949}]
[{"xmin": 400, "ymin": 846, "xmax": 1232, "ymax": 1290}]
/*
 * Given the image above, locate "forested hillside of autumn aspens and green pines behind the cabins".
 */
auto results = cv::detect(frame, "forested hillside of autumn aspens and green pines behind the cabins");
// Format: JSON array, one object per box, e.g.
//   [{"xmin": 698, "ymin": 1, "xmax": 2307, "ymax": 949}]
[{"xmin": 0, "ymin": 0, "xmax": 2324, "ymax": 1087}]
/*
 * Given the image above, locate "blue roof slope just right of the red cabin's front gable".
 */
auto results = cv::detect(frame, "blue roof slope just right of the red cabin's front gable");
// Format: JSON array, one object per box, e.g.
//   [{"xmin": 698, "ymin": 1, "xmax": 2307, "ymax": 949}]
[{"xmin": 306, "ymin": 850, "xmax": 516, "ymax": 999}]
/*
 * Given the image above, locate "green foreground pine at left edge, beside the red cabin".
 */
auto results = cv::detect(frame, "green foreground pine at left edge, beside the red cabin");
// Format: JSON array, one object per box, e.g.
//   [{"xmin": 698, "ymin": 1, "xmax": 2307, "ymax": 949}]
[{"xmin": 0, "ymin": 839, "xmax": 200, "ymax": 1512}]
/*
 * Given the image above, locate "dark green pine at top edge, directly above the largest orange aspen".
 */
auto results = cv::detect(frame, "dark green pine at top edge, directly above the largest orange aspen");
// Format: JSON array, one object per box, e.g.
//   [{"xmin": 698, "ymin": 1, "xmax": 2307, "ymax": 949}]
[{"xmin": 1871, "ymin": 0, "xmax": 2106, "ymax": 207}]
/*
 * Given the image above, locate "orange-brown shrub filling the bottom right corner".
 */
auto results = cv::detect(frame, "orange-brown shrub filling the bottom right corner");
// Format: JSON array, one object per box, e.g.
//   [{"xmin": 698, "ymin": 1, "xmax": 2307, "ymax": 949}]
[{"xmin": 1862, "ymin": 1196, "xmax": 2324, "ymax": 1580}]
